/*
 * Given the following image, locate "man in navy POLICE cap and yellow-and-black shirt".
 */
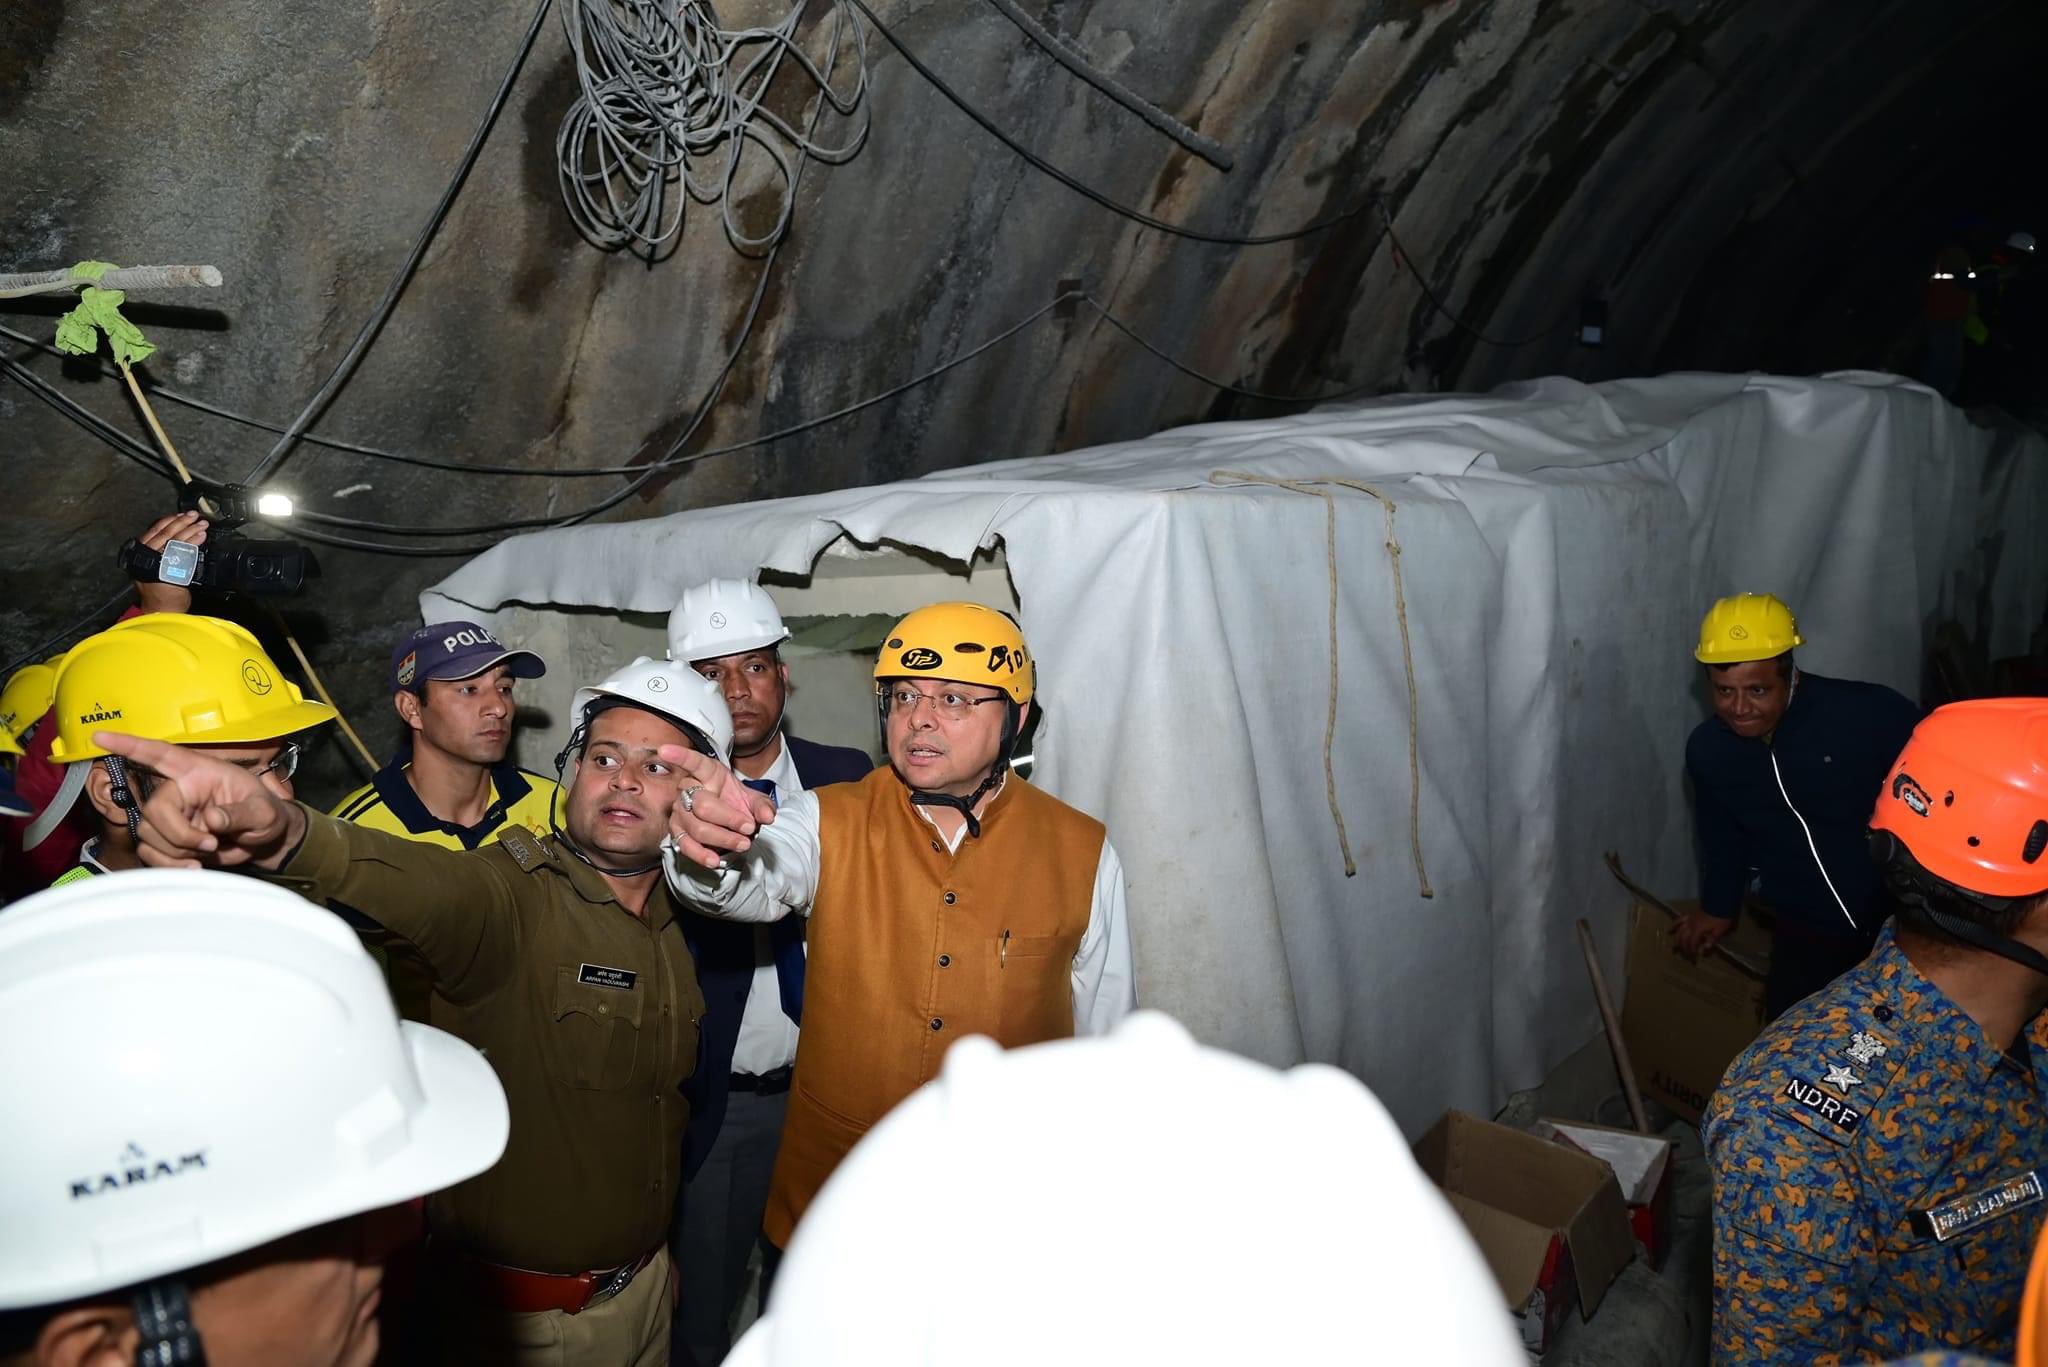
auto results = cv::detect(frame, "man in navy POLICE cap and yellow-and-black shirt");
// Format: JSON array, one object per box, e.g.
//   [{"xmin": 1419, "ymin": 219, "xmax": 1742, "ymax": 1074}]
[{"xmin": 332, "ymin": 621, "xmax": 561, "ymax": 1021}]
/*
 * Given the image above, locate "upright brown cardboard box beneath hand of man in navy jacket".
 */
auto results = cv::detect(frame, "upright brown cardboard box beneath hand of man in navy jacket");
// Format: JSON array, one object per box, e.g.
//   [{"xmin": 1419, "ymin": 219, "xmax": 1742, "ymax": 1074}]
[{"xmin": 1622, "ymin": 902, "xmax": 1772, "ymax": 1123}]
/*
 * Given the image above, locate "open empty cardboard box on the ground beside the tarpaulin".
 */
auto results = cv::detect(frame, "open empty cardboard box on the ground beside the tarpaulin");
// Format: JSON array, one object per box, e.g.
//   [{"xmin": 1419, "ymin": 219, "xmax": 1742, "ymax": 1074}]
[{"xmin": 1415, "ymin": 1111, "xmax": 1636, "ymax": 1353}]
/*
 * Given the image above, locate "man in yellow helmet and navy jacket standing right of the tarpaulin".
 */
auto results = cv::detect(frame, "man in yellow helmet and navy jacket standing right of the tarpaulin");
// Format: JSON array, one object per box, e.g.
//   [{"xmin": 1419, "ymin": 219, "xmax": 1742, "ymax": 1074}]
[{"xmin": 1675, "ymin": 594, "xmax": 1919, "ymax": 1019}]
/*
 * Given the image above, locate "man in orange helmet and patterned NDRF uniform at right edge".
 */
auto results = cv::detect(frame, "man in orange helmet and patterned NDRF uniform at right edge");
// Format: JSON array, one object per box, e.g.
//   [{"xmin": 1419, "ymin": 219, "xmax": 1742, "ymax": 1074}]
[{"xmin": 1704, "ymin": 699, "xmax": 2048, "ymax": 1367}]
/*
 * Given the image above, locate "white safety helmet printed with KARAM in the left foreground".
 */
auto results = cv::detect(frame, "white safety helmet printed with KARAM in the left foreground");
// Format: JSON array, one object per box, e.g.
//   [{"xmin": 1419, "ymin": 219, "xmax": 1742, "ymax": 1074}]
[{"xmin": 0, "ymin": 869, "xmax": 508, "ymax": 1310}]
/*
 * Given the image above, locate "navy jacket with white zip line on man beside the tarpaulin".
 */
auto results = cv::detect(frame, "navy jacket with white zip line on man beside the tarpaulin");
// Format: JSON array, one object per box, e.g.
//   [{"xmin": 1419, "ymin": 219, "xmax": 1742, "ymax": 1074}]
[{"xmin": 1686, "ymin": 670, "xmax": 1921, "ymax": 935}]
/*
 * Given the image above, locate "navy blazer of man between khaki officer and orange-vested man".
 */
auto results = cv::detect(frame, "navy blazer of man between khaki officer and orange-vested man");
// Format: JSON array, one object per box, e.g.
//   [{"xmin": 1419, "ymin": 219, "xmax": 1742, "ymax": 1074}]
[{"xmin": 682, "ymin": 734, "xmax": 874, "ymax": 1180}]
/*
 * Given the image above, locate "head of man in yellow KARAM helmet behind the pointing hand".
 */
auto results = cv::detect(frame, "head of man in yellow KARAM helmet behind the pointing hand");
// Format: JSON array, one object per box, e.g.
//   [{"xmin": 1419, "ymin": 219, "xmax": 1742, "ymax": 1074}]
[{"xmin": 25, "ymin": 613, "xmax": 334, "ymax": 885}]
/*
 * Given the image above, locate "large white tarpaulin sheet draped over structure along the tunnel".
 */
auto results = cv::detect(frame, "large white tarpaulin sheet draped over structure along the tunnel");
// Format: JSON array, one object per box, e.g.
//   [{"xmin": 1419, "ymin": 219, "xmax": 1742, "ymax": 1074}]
[{"xmin": 422, "ymin": 375, "xmax": 2048, "ymax": 1131}]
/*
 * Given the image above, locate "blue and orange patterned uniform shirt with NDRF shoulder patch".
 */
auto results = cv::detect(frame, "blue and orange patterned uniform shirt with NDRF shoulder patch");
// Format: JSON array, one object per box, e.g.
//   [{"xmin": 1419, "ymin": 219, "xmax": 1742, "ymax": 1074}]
[{"xmin": 1704, "ymin": 926, "xmax": 2048, "ymax": 1367}]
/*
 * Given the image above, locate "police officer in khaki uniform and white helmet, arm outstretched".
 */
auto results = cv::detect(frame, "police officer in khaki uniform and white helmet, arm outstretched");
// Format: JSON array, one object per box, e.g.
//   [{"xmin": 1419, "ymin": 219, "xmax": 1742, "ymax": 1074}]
[{"xmin": 96, "ymin": 660, "xmax": 733, "ymax": 1367}]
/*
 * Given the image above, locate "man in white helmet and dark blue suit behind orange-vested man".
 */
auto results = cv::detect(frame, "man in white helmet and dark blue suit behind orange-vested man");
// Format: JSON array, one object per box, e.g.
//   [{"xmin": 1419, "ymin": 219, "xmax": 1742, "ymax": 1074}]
[{"xmin": 668, "ymin": 580, "xmax": 874, "ymax": 1367}]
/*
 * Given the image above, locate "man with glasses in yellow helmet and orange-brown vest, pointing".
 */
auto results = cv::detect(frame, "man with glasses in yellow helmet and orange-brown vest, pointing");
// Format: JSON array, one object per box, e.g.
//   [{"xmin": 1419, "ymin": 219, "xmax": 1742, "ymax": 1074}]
[{"xmin": 662, "ymin": 603, "xmax": 1135, "ymax": 1295}]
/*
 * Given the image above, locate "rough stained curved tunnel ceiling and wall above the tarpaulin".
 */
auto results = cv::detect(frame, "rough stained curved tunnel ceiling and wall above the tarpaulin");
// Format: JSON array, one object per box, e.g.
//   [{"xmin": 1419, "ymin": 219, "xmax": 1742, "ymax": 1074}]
[{"xmin": 0, "ymin": 0, "xmax": 2048, "ymax": 786}]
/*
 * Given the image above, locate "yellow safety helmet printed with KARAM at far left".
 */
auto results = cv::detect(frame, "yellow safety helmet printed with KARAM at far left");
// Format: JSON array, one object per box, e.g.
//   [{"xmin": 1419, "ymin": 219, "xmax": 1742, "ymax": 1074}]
[{"xmin": 49, "ymin": 613, "xmax": 334, "ymax": 764}]
